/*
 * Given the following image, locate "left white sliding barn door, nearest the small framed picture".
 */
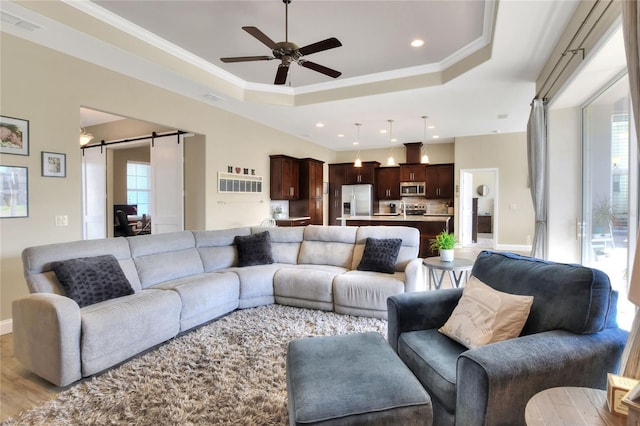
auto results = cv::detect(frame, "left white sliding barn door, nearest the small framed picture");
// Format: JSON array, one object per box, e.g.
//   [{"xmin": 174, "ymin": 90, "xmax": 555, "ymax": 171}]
[{"xmin": 82, "ymin": 148, "xmax": 107, "ymax": 240}]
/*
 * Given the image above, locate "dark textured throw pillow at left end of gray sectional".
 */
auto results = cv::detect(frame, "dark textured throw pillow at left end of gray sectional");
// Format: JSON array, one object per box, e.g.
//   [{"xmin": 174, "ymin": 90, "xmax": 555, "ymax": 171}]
[{"xmin": 51, "ymin": 254, "xmax": 134, "ymax": 308}]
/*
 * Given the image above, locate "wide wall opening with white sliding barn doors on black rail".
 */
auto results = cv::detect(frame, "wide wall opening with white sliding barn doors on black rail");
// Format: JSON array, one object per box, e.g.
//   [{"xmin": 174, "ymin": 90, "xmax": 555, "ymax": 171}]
[{"xmin": 81, "ymin": 108, "xmax": 185, "ymax": 239}]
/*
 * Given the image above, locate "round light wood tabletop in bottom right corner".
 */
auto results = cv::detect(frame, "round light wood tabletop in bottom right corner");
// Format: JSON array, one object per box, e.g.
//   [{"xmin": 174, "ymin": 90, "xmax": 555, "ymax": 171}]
[{"xmin": 524, "ymin": 387, "xmax": 627, "ymax": 426}]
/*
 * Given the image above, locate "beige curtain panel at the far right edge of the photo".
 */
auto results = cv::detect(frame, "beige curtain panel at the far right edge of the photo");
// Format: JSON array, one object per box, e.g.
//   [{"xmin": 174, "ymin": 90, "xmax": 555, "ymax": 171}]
[{"xmin": 621, "ymin": 0, "xmax": 640, "ymax": 379}]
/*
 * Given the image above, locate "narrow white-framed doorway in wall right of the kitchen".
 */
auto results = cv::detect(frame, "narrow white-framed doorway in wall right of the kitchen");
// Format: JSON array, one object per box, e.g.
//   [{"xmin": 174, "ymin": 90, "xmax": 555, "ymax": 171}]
[{"xmin": 458, "ymin": 168, "xmax": 498, "ymax": 249}]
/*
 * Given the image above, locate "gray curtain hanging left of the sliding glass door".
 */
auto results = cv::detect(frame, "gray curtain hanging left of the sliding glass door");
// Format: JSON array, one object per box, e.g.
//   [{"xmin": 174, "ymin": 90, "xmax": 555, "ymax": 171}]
[{"xmin": 527, "ymin": 99, "xmax": 547, "ymax": 259}]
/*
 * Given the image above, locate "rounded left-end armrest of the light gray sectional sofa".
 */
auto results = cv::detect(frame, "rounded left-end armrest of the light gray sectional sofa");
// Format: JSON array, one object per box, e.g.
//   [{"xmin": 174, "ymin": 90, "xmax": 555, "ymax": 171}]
[{"xmin": 12, "ymin": 293, "xmax": 82, "ymax": 386}]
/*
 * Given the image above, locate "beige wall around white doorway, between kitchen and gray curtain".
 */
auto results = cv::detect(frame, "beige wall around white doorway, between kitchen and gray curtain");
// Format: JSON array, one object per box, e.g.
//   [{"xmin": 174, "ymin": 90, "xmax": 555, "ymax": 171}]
[{"xmin": 455, "ymin": 133, "xmax": 535, "ymax": 249}]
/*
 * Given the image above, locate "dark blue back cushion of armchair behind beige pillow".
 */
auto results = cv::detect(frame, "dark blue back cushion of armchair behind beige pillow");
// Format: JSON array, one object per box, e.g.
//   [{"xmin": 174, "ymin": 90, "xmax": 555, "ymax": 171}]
[{"xmin": 471, "ymin": 251, "xmax": 615, "ymax": 335}]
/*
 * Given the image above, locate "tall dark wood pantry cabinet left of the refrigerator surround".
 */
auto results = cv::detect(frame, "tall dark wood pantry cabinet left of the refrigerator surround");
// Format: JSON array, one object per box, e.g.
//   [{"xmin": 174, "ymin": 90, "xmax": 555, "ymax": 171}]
[{"xmin": 289, "ymin": 158, "xmax": 324, "ymax": 225}]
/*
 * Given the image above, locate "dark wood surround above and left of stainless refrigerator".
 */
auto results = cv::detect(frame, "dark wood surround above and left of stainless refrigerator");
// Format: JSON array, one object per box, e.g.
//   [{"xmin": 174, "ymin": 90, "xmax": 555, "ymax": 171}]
[{"xmin": 329, "ymin": 161, "xmax": 380, "ymax": 225}]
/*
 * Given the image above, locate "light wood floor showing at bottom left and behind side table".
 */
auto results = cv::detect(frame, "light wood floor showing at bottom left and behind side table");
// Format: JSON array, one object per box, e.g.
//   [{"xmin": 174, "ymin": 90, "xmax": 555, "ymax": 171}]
[{"xmin": 0, "ymin": 247, "xmax": 496, "ymax": 422}]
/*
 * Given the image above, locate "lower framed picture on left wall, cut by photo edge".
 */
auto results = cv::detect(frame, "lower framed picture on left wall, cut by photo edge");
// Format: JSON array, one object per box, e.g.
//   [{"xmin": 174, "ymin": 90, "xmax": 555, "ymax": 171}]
[{"xmin": 0, "ymin": 166, "xmax": 29, "ymax": 218}]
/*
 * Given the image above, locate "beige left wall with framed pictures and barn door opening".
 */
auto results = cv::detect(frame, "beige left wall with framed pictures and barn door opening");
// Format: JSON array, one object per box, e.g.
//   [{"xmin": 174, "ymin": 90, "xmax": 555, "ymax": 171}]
[{"xmin": 0, "ymin": 33, "xmax": 335, "ymax": 320}]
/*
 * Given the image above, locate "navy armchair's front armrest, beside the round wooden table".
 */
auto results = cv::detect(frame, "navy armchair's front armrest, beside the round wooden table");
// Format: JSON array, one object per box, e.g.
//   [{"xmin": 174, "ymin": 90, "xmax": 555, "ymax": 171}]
[{"xmin": 456, "ymin": 328, "xmax": 627, "ymax": 426}]
